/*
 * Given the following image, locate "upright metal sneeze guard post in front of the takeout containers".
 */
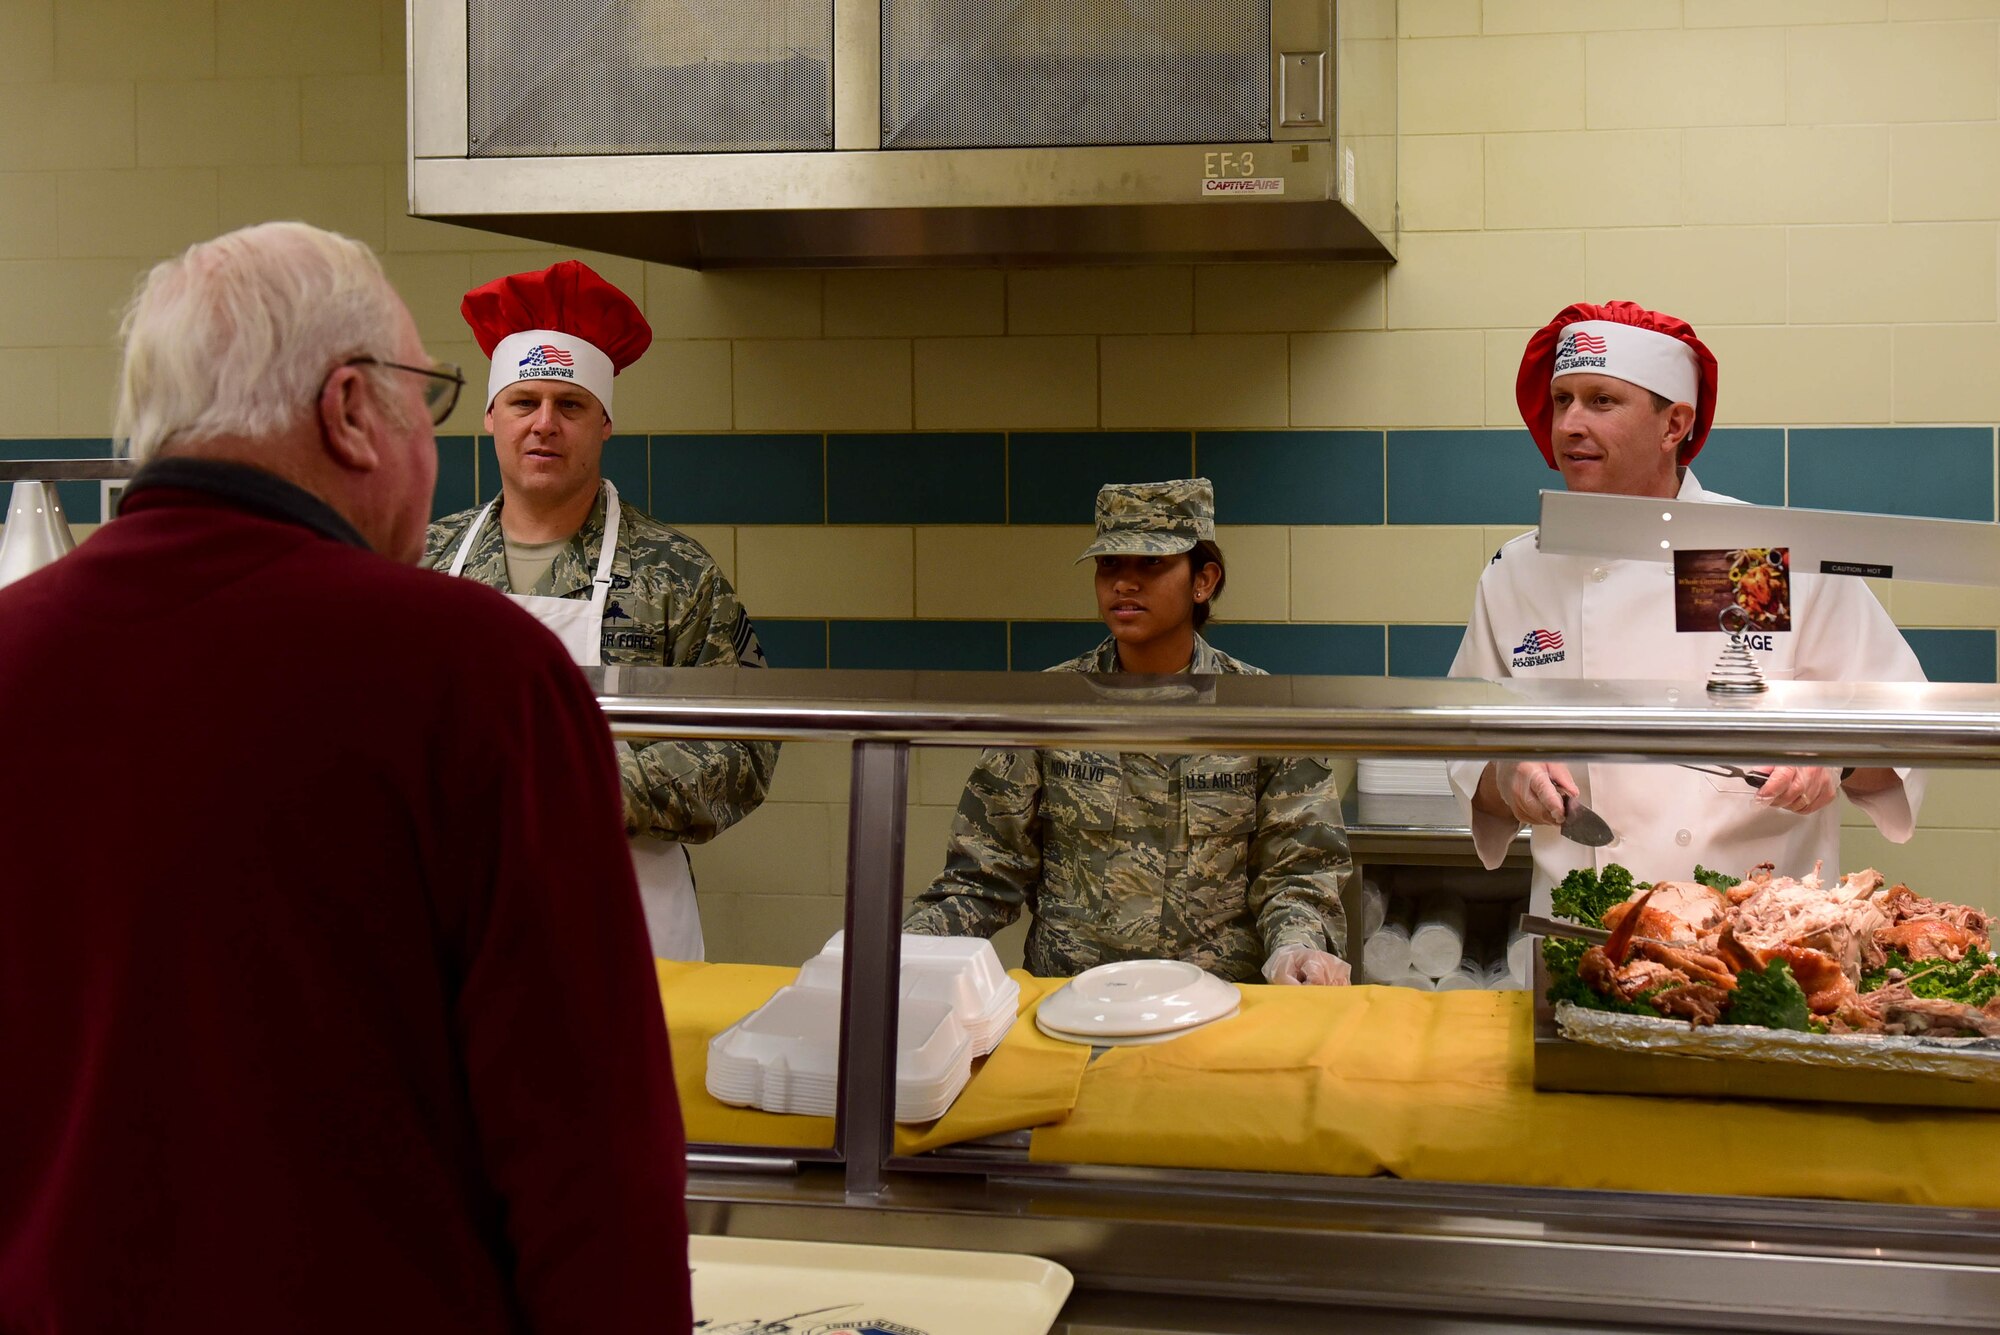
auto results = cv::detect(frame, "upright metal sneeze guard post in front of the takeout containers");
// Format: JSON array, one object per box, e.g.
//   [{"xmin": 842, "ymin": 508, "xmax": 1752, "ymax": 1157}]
[{"xmin": 834, "ymin": 741, "xmax": 910, "ymax": 1197}]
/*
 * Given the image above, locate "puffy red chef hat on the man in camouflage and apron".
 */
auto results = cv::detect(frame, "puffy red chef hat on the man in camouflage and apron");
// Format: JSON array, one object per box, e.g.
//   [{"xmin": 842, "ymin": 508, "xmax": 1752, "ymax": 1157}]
[{"xmin": 458, "ymin": 260, "xmax": 652, "ymax": 418}]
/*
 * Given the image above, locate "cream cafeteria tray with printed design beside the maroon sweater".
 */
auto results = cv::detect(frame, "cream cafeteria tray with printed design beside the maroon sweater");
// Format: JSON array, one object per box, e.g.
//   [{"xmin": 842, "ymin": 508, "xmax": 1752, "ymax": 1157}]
[{"xmin": 688, "ymin": 1235, "xmax": 1072, "ymax": 1335}]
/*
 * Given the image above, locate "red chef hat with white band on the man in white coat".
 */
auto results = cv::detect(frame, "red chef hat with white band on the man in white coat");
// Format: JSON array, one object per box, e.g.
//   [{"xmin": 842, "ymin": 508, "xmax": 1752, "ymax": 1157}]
[{"xmin": 1514, "ymin": 302, "xmax": 1716, "ymax": 468}]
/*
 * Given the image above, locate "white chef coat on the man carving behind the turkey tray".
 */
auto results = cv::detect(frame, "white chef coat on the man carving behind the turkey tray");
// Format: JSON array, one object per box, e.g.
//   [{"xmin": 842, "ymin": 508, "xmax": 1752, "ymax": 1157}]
[{"xmin": 1450, "ymin": 463, "xmax": 1924, "ymax": 913}]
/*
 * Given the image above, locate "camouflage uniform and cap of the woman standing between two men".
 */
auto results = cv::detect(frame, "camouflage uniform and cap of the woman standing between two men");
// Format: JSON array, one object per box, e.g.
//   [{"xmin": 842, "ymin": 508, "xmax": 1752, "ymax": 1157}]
[{"xmin": 904, "ymin": 480, "xmax": 1352, "ymax": 981}]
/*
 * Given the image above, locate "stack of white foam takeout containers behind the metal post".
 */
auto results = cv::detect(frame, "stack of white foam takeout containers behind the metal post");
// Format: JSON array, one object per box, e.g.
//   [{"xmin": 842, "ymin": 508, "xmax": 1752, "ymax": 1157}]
[{"xmin": 706, "ymin": 933, "xmax": 1020, "ymax": 1121}]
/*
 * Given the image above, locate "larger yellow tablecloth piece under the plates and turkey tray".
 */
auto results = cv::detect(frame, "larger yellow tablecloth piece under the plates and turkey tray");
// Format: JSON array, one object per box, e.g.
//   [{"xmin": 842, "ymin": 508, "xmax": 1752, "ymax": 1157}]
[{"xmin": 1032, "ymin": 987, "xmax": 2000, "ymax": 1209}]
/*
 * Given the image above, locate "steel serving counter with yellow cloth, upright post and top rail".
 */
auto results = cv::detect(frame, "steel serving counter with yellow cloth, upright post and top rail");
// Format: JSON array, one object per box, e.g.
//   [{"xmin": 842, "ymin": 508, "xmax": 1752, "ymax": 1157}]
[{"xmin": 598, "ymin": 669, "xmax": 2000, "ymax": 1331}]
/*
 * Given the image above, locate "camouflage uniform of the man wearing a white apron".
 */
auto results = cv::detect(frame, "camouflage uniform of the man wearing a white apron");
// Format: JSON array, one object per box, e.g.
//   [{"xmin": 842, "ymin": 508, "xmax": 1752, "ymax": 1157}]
[{"xmin": 424, "ymin": 488, "xmax": 778, "ymax": 843}]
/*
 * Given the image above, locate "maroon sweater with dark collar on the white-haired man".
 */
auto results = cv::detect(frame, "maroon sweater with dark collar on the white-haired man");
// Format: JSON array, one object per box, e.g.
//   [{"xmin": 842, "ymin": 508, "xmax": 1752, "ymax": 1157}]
[{"xmin": 0, "ymin": 462, "xmax": 690, "ymax": 1335}]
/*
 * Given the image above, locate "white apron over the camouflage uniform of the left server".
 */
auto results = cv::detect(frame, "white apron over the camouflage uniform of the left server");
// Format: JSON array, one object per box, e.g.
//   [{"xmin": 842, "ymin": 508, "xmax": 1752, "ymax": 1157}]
[{"xmin": 450, "ymin": 480, "xmax": 704, "ymax": 959}]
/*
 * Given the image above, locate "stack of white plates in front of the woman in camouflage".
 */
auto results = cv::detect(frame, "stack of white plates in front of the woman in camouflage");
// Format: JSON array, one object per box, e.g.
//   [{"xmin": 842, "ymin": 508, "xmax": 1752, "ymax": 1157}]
[{"xmin": 1034, "ymin": 959, "xmax": 1242, "ymax": 1047}]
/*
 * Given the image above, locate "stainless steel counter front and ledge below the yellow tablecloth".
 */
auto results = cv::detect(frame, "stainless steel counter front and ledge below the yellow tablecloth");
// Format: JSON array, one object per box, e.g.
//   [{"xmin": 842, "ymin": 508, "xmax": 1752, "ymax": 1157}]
[{"xmin": 688, "ymin": 1151, "xmax": 2000, "ymax": 1335}]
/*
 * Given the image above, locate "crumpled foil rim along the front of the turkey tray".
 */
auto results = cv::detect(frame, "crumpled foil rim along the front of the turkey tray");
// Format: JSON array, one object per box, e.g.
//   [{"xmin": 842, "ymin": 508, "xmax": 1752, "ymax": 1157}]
[{"xmin": 1554, "ymin": 1001, "xmax": 2000, "ymax": 1089}]
